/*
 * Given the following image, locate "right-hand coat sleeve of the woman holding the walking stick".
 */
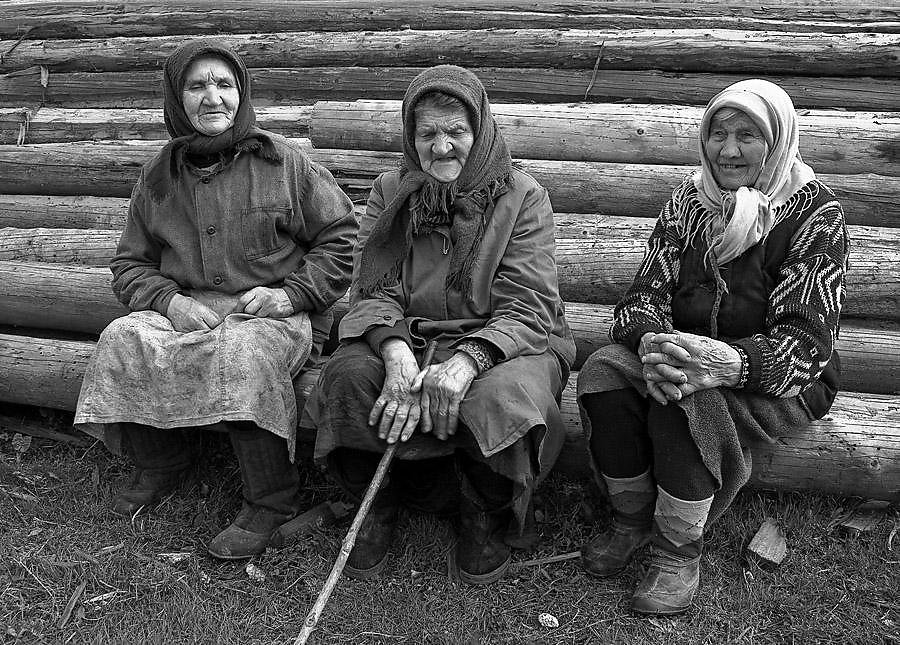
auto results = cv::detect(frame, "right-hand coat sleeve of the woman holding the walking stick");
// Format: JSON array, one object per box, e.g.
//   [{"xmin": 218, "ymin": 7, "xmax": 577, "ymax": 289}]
[{"xmin": 457, "ymin": 186, "xmax": 560, "ymax": 361}]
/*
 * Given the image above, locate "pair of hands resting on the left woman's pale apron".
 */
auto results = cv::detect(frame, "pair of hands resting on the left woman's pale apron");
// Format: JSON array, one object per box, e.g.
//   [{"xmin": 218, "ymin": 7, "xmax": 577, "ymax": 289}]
[{"xmin": 166, "ymin": 287, "xmax": 294, "ymax": 332}]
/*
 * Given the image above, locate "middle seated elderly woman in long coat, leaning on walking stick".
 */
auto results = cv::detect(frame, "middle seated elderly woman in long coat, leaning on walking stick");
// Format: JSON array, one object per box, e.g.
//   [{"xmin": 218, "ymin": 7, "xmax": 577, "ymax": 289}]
[{"xmin": 306, "ymin": 65, "xmax": 575, "ymax": 584}]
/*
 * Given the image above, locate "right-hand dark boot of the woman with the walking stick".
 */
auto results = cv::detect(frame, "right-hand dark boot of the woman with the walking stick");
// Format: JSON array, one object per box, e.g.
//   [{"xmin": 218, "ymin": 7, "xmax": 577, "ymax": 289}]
[{"xmin": 456, "ymin": 456, "xmax": 513, "ymax": 585}]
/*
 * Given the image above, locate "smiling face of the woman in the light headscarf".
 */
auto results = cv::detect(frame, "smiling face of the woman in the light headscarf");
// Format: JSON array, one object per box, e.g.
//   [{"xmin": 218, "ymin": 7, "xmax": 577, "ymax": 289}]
[{"xmin": 706, "ymin": 109, "xmax": 767, "ymax": 190}]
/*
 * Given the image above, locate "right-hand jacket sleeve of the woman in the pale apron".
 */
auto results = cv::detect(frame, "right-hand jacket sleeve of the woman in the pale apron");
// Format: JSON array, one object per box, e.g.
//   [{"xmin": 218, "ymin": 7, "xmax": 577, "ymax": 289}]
[{"xmin": 284, "ymin": 156, "xmax": 357, "ymax": 312}]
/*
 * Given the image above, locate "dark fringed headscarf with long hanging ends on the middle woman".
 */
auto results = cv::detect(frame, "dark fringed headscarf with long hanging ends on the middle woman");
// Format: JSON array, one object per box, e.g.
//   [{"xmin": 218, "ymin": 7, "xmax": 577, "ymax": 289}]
[{"xmin": 358, "ymin": 65, "xmax": 512, "ymax": 296}]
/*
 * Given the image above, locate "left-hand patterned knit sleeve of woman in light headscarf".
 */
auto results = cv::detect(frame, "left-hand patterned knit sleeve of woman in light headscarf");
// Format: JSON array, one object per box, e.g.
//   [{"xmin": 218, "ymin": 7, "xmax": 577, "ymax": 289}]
[{"xmin": 609, "ymin": 195, "xmax": 682, "ymax": 352}]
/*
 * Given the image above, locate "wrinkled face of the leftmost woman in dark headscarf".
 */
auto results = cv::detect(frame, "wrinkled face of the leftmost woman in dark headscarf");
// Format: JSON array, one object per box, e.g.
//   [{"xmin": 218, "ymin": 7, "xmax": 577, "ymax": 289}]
[{"xmin": 181, "ymin": 56, "xmax": 240, "ymax": 137}]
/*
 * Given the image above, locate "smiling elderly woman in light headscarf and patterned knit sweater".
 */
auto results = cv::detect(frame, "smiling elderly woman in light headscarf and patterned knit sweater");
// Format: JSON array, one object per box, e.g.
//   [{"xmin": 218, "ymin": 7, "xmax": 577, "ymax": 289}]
[{"xmin": 578, "ymin": 80, "xmax": 848, "ymax": 614}]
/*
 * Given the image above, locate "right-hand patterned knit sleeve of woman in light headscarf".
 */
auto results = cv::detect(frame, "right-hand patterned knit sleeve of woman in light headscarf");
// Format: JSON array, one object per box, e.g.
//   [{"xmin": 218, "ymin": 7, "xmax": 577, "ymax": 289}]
[{"xmin": 733, "ymin": 201, "xmax": 849, "ymax": 397}]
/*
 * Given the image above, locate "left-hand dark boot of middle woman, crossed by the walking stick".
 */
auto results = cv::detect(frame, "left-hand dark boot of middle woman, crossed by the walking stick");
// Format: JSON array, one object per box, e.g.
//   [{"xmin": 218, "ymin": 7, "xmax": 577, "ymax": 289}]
[{"xmin": 328, "ymin": 448, "xmax": 399, "ymax": 580}]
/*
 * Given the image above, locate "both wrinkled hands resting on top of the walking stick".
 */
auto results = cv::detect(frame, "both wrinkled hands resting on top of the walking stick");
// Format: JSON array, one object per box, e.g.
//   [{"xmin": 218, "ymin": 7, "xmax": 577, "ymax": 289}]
[{"xmin": 369, "ymin": 338, "xmax": 478, "ymax": 443}]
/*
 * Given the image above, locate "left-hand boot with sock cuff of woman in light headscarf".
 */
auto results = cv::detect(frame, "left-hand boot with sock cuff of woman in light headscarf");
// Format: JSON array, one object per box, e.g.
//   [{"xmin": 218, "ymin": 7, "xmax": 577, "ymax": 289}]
[{"xmin": 581, "ymin": 470, "xmax": 656, "ymax": 578}]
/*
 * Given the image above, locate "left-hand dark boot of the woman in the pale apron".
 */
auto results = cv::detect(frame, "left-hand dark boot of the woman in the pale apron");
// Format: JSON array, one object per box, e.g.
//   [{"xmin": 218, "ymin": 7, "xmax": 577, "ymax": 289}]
[{"xmin": 112, "ymin": 423, "xmax": 195, "ymax": 517}]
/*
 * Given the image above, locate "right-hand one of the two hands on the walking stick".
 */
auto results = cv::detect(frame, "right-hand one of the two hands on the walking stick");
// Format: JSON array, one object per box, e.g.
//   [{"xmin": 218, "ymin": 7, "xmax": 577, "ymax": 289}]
[{"xmin": 413, "ymin": 352, "xmax": 478, "ymax": 441}]
